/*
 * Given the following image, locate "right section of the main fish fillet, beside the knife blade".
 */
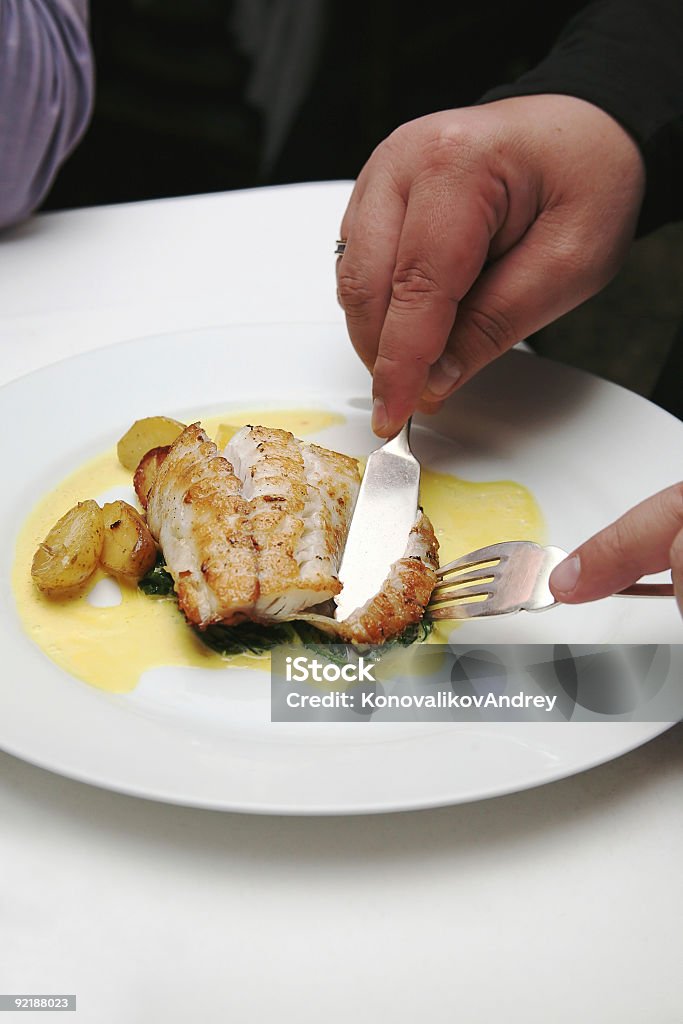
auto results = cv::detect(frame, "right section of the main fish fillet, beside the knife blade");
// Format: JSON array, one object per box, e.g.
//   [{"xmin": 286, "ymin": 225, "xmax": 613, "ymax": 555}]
[{"xmin": 225, "ymin": 426, "xmax": 359, "ymax": 623}]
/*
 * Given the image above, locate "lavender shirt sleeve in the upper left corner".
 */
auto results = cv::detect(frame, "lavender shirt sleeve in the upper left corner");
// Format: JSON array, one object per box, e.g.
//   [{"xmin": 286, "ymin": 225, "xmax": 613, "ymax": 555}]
[{"xmin": 0, "ymin": 0, "xmax": 94, "ymax": 227}]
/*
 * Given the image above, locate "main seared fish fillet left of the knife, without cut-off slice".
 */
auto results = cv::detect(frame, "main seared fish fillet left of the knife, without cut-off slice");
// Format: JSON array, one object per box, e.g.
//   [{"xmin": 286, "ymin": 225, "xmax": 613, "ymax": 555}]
[{"xmin": 147, "ymin": 424, "xmax": 359, "ymax": 628}]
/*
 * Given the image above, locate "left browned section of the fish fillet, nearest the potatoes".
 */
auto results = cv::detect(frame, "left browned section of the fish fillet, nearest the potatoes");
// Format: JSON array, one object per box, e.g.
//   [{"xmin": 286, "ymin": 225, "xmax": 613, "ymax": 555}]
[{"xmin": 147, "ymin": 423, "xmax": 258, "ymax": 628}]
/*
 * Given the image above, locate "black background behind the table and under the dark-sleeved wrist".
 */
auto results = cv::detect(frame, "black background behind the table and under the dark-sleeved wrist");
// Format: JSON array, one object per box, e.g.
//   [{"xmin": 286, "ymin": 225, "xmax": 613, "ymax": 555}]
[{"xmin": 44, "ymin": 0, "xmax": 683, "ymax": 415}]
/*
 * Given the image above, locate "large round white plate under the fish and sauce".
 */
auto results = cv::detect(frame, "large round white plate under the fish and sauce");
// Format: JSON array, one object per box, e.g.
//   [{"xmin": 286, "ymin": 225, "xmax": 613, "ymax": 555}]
[{"xmin": 0, "ymin": 325, "xmax": 683, "ymax": 814}]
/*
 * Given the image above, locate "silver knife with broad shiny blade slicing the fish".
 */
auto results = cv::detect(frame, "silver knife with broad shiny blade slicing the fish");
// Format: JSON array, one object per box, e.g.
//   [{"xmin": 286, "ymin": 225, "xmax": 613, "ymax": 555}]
[{"xmin": 335, "ymin": 420, "xmax": 420, "ymax": 622}]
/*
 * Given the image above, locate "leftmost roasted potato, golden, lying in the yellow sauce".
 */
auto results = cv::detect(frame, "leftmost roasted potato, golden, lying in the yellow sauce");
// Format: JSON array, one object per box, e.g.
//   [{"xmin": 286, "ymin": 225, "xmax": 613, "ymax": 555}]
[{"xmin": 31, "ymin": 501, "xmax": 104, "ymax": 597}]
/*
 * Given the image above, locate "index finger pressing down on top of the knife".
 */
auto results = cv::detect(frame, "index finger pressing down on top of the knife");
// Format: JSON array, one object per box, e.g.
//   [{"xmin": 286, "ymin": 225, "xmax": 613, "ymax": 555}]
[{"xmin": 373, "ymin": 177, "xmax": 494, "ymax": 437}]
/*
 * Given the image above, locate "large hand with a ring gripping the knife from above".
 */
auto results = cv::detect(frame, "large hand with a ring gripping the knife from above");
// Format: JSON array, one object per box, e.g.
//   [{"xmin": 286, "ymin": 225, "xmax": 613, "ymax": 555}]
[{"xmin": 337, "ymin": 95, "xmax": 645, "ymax": 437}]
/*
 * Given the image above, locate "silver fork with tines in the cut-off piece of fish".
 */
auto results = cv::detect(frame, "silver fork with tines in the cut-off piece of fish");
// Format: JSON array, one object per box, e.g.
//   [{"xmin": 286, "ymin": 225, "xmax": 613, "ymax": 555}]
[{"xmin": 427, "ymin": 541, "xmax": 674, "ymax": 618}]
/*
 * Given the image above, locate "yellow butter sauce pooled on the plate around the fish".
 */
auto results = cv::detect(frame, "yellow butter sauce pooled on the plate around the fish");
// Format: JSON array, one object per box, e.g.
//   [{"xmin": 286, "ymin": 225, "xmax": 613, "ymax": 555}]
[{"xmin": 12, "ymin": 410, "xmax": 545, "ymax": 693}]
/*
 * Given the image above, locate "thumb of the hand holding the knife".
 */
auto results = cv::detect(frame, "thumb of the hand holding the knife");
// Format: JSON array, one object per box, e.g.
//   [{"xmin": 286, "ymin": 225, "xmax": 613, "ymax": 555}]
[{"xmin": 423, "ymin": 208, "xmax": 617, "ymax": 402}]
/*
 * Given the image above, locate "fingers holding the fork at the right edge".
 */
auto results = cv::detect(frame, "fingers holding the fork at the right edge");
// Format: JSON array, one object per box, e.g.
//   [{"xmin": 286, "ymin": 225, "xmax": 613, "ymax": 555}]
[{"xmin": 550, "ymin": 482, "xmax": 683, "ymax": 615}]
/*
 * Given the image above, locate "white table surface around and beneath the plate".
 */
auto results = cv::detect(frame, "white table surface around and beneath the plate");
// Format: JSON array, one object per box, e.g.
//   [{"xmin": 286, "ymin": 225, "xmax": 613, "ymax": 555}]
[{"xmin": 0, "ymin": 182, "xmax": 683, "ymax": 1024}]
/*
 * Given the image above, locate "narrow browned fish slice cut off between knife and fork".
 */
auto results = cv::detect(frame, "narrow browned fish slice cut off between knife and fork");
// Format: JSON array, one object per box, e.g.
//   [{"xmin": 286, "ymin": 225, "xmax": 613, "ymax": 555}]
[{"xmin": 293, "ymin": 509, "xmax": 438, "ymax": 644}]
